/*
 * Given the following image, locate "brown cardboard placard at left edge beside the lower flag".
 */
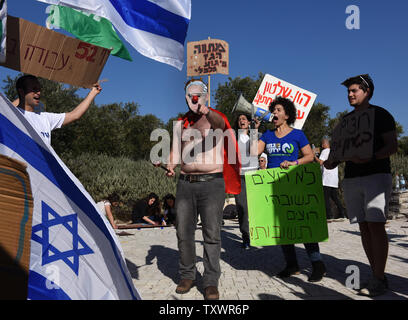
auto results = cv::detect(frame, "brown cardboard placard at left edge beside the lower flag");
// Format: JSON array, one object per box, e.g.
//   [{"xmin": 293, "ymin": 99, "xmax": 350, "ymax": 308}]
[{"xmin": 0, "ymin": 155, "xmax": 33, "ymax": 299}]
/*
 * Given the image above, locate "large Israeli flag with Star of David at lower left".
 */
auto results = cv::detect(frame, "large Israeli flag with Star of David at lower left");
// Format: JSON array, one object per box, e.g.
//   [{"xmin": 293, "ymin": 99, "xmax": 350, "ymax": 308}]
[{"xmin": 0, "ymin": 93, "xmax": 141, "ymax": 300}]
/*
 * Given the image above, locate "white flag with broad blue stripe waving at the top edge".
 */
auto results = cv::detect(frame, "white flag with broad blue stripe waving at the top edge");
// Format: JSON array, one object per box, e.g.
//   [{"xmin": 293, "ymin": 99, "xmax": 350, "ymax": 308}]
[{"xmin": 38, "ymin": 0, "xmax": 191, "ymax": 70}]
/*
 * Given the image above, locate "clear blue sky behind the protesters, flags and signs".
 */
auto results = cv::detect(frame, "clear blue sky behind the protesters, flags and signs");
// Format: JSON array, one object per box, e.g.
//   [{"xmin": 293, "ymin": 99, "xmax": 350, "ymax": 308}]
[{"xmin": 0, "ymin": 0, "xmax": 408, "ymax": 135}]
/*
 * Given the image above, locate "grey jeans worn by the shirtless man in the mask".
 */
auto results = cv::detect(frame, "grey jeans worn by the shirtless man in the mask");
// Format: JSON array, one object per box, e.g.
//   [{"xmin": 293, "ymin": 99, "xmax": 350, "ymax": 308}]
[{"xmin": 176, "ymin": 178, "xmax": 225, "ymax": 288}]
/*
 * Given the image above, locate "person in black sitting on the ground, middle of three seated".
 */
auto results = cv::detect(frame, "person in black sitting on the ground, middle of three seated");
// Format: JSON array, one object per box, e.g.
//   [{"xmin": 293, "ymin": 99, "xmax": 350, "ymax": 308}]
[{"xmin": 132, "ymin": 192, "xmax": 160, "ymax": 226}]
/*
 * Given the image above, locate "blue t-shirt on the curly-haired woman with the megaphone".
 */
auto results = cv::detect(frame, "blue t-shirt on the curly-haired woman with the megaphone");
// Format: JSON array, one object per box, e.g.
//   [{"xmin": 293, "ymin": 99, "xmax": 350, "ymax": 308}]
[{"xmin": 260, "ymin": 129, "xmax": 309, "ymax": 168}]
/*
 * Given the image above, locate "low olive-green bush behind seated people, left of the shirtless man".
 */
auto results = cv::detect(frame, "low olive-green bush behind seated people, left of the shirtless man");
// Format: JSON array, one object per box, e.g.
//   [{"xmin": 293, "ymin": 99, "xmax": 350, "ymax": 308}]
[{"xmin": 61, "ymin": 153, "xmax": 176, "ymax": 220}]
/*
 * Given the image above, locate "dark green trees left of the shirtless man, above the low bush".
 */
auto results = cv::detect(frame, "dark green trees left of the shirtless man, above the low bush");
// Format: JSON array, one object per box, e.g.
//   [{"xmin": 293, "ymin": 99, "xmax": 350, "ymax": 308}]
[{"xmin": 3, "ymin": 75, "xmax": 164, "ymax": 160}]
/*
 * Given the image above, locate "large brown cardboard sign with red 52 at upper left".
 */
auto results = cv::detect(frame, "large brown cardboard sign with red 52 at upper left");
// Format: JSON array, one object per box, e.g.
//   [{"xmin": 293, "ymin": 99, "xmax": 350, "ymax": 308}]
[{"xmin": 0, "ymin": 16, "xmax": 110, "ymax": 88}]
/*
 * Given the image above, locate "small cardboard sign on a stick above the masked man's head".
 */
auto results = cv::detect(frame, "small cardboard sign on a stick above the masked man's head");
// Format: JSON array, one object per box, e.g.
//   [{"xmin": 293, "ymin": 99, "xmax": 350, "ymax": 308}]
[{"xmin": 187, "ymin": 39, "xmax": 229, "ymax": 77}]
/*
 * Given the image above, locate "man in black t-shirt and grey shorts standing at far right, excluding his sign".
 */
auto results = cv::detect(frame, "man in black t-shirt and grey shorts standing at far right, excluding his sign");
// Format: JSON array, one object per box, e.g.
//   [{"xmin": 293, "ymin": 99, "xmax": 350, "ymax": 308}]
[{"xmin": 324, "ymin": 74, "xmax": 398, "ymax": 297}]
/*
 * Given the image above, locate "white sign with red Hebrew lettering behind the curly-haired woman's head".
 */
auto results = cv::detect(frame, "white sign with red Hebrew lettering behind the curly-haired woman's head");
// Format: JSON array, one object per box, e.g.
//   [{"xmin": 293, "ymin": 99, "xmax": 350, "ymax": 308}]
[{"xmin": 252, "ymin": 74, "xmax": 317, "ymax": 129}]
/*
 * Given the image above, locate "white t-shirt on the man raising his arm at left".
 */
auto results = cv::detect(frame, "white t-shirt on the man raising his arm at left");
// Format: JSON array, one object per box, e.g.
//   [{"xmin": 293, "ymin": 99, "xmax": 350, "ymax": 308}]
[{"xmin": 18, "ymin": 108, "xmax": 65, "ymax": 145}]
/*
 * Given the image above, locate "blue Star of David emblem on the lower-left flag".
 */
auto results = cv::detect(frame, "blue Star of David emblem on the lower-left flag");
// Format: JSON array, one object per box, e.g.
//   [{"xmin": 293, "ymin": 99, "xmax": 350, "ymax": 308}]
[{"xmin": 32, "ymin": 201, "xmax": 94, "ymax": 275}]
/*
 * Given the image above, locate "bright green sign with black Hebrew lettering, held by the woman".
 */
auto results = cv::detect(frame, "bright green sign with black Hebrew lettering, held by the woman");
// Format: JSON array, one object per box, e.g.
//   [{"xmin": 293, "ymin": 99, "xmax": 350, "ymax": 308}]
[{"xmin": 245, "ymin": 163, "xmax": 328, "ymax": 246}]
